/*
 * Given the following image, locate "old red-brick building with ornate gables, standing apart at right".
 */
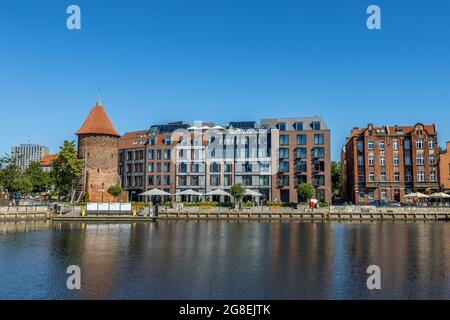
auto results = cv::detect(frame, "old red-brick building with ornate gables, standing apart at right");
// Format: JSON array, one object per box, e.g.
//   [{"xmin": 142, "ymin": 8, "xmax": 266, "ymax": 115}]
[{"xmin": 342, "ymin": 123, "xmax": 439, "ymax": 204}]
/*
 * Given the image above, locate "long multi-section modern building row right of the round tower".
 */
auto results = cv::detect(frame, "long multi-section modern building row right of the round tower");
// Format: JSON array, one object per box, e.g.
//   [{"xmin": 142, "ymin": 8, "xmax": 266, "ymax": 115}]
[{"xmin": 119, "ymin": 117, "xmax": 331, "ymax": 202}]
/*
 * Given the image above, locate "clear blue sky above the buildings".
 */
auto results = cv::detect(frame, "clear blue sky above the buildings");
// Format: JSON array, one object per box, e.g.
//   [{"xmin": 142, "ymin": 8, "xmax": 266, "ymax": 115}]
[{"xmin": 0, "ymin": 0, "xmax": 450, "ymax": 159}]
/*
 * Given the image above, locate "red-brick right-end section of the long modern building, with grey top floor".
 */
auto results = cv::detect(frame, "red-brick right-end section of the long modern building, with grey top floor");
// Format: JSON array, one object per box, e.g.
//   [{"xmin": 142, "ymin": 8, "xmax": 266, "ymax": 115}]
[{"xmin": 261, "ymin": 117, "xmax": 331, "ymax": 202}]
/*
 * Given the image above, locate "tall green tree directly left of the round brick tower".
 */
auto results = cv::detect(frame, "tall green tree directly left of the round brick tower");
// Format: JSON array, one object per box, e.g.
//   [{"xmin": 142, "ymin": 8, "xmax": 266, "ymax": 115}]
[{"xmin": 51, "ymin": 140, "xmax": 81, "ymax": 198}]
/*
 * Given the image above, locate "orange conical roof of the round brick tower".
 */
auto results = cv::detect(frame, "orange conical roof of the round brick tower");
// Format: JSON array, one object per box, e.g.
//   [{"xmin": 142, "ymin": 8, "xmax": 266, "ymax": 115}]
[{"xmin": 75, "ymin": 103, "xmax": 120, "ymax": 137}]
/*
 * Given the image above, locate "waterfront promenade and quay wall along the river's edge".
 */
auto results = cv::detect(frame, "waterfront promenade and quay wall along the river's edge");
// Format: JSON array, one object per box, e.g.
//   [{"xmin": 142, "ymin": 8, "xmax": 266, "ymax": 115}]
[{"xmin": 0, "ymin": 205, "xmax": 450, "ymax": 221}]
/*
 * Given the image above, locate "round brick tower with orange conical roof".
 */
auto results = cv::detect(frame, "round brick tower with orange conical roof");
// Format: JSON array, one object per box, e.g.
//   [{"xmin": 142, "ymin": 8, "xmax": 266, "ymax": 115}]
[{"xmin": 74, "ymin": 102, "xmax": 120, "ymax": 202}]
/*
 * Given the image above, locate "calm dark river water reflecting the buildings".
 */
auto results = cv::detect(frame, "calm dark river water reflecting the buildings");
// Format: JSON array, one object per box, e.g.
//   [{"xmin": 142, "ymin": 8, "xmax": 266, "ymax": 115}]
[{"xmin": 0, "ymin": 221, "xmax": 450, "ymax": 299}]
